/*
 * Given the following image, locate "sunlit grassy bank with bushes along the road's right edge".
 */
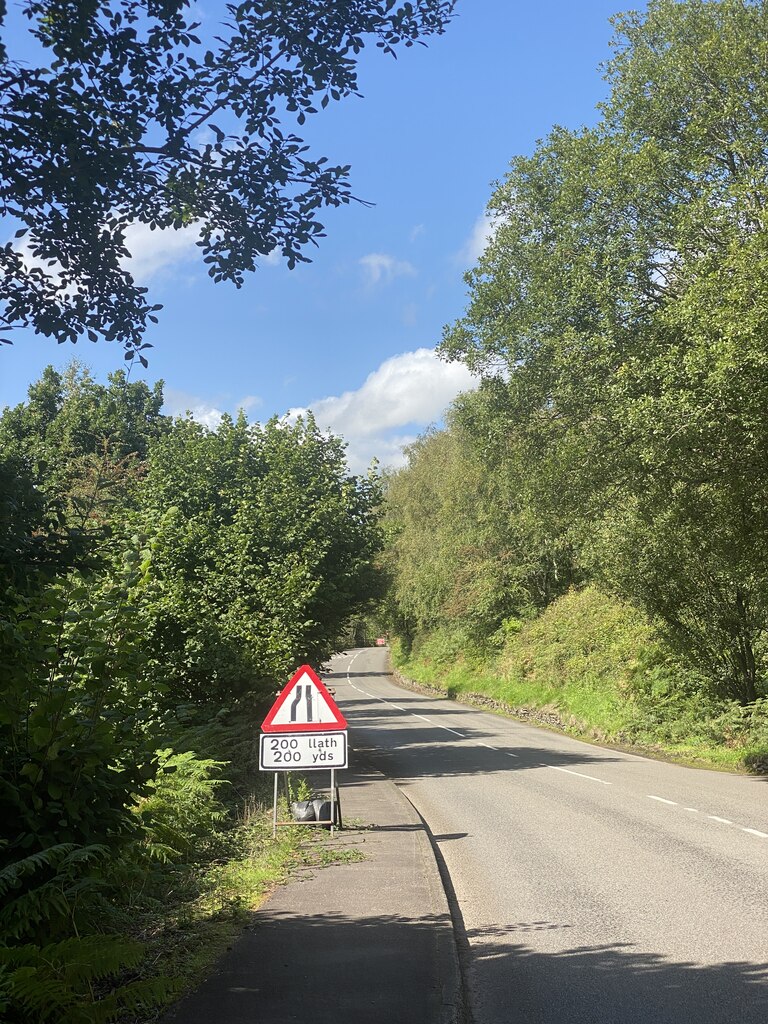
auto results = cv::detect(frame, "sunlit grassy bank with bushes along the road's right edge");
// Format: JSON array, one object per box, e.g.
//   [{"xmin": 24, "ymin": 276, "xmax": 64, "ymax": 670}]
[{"xmin": 392, "ymin": 588, "xmax": 768, "ymax": 773}]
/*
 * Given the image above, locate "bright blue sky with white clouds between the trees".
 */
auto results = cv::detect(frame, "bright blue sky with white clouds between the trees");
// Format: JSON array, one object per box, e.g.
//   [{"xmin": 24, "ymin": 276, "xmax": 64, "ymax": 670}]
[{"xmin": 0, "ymin": 0, "xmax": 626, "ymax": 471}]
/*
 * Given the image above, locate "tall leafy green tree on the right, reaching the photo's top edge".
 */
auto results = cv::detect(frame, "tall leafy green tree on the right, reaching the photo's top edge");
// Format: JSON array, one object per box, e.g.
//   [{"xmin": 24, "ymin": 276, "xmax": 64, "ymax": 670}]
[{"xmin": 443, "ymin": 0, "xmax": 768, "ymax": 701}]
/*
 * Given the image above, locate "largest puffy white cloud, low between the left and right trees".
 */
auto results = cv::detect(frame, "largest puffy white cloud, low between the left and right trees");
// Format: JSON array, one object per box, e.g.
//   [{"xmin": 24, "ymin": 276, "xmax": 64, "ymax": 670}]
[{"xmin": 288, "ymin": 348, "xmax": 476, "ymax": 473}]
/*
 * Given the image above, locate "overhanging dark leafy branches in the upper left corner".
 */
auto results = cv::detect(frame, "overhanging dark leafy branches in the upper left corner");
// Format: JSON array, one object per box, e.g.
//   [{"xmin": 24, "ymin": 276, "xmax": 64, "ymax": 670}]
[{"xmin": 0, "ymin": 0, "xmax": 455, "ymax": 362}]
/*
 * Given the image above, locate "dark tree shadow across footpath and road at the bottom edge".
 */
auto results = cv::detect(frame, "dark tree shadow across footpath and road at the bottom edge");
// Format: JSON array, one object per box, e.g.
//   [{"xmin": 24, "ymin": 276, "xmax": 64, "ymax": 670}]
[{"xmin": 167, "ymin": 912, "xmax": 768, "ymax": 1024}]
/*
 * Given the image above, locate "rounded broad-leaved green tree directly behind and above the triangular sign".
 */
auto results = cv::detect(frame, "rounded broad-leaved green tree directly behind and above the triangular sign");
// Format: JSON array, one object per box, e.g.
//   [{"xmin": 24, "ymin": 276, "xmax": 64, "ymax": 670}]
[{"xmin": 139, "ymin": 407, "xmax": 385, "ymax": 701}]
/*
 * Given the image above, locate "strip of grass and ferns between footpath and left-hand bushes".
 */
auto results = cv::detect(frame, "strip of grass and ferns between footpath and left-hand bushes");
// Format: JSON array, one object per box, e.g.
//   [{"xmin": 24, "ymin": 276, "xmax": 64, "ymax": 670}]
[{"xmin": 115, "ymin": 713, "xmax": 362, "ymax": 1024}]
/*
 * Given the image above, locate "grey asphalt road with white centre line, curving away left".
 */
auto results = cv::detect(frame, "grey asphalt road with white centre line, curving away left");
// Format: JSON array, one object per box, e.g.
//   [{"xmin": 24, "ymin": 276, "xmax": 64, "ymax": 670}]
[{"xmin": 325, "ymin": 649, "xmax": 768, "ymax": 1024}]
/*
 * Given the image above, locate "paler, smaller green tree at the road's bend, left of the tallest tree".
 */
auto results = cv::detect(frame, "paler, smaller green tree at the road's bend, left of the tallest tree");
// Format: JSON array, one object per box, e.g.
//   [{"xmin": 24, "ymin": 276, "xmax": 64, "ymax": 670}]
[{"xmin": 385, "ymin": 384, "xmax": 574, "ymax": 648}]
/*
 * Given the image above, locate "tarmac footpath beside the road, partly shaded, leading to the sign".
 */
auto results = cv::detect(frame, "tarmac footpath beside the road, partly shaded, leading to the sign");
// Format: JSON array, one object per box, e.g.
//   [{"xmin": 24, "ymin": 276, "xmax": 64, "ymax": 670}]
[{"xmin": 164, "ymin": 769, "xmax": 462, "ymax": 1024}]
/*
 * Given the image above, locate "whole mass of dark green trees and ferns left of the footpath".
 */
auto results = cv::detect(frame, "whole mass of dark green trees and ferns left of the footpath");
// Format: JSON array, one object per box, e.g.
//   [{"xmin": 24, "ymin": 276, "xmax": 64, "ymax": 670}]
[{"xmin": 0, "ymin": 367, "xmax": 380, "ymax": 1024}]
